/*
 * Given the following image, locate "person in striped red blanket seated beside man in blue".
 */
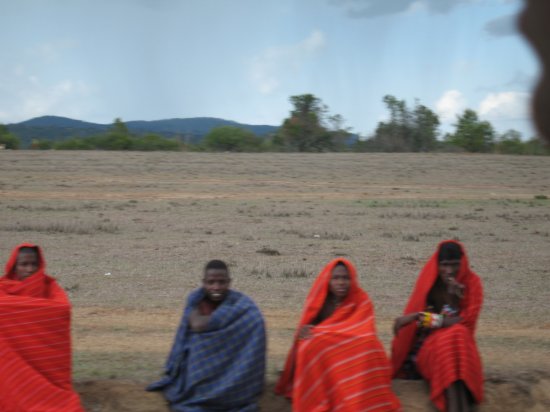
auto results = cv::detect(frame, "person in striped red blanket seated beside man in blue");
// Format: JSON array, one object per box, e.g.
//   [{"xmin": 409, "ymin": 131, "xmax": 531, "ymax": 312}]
[{"xmin": 275, "ymin": 259, "xmax": 401, "ymax": 412}]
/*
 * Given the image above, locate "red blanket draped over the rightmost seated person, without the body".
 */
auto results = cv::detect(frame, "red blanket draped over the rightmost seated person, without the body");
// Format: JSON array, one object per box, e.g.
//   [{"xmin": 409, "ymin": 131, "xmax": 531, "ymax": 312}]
[{"xmin": 392, "ymin": 242, "xmax": 483, "ymax": 410}]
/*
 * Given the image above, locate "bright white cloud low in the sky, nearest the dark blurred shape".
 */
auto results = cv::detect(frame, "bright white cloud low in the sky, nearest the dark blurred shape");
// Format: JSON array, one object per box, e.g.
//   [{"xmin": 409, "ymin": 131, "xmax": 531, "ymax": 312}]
[{"xmin": 479, "ymin": 92, "xmax": 530, "ymax": 120}]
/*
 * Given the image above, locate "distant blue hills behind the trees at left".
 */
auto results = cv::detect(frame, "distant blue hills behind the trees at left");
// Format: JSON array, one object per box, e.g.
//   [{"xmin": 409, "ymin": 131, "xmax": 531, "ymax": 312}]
[{"xmin": 6, "ymin": 116, "xmax": 278, "ymax": 147}]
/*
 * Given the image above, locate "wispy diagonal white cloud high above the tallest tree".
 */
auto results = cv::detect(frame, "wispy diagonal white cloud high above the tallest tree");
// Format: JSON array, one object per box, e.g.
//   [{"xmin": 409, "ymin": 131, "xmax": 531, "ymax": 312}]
[{"xmin": 250, "ymin": 30, "xmax": 325, "ymax": 94}]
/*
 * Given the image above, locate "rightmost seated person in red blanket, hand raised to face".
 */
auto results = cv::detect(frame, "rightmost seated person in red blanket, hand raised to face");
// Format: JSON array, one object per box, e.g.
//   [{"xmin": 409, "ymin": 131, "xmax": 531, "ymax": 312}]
[{"xmin": 392, "ymin": 241, "xmax": 483, "ymax": 412}]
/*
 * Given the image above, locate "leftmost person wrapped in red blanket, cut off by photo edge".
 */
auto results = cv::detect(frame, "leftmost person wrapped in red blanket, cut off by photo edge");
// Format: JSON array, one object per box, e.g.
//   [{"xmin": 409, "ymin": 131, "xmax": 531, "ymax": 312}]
[{"xmin": 0, "ymin": 243, "xmax": 84, "ymax": 412}]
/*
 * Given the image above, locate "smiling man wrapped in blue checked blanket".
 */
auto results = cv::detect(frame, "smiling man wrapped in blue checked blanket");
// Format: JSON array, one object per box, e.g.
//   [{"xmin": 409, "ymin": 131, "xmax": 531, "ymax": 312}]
[{"xmin": 147, "ymin": 260, "xmax": 266, "ymax": 412}]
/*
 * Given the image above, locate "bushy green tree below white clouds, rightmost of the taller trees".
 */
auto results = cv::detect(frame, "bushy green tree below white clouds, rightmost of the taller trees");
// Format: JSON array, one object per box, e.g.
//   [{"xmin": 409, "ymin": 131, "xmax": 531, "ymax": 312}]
[{"xmin": 447, "ymin": 109, "xmax": 495, "ymax": 153}]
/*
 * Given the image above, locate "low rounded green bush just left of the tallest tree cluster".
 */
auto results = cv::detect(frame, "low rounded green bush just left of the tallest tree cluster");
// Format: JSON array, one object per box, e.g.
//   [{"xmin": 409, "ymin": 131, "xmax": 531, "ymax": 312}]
[{"xmin": 204, "ymin": 126, "xmax": 262, "ymax": 152}]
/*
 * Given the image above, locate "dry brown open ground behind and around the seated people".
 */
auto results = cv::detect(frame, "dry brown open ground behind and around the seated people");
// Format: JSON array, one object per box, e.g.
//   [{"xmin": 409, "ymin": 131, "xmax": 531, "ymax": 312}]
[{"xmin": 0, "ymin": 151, "xmax": 550, "ymax": 411}]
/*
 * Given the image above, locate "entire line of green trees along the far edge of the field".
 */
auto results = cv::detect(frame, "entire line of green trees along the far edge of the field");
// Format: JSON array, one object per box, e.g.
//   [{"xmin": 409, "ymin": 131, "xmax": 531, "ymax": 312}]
[{"xmin": 0, "ymin": 94, "xmax": 550, "ymax": 155}]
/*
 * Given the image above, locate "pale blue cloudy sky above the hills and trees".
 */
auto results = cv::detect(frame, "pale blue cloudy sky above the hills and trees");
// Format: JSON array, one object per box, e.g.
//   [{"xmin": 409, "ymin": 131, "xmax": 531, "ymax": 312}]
[{"xmin": 0, "ymin": 0, "xmax": 539, "ymax": 137}]
